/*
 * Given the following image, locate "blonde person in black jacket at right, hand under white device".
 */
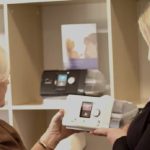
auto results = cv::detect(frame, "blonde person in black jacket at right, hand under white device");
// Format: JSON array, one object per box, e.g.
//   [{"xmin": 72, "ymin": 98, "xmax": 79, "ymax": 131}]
[{"xmin": 91, "ymin": 3, "xmax": 150, "ymax": 150}]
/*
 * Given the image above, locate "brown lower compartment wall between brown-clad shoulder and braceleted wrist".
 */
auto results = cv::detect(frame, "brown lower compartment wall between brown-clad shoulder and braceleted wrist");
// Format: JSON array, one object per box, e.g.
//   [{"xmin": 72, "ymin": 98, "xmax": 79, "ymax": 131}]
[{"xmin": 13, "ymin": 110, "xmax": 55, "ymax": 149}]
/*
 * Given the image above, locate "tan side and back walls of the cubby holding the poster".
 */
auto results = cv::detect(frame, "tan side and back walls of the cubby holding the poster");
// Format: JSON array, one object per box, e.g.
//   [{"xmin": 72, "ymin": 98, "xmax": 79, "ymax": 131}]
[{"xmin": 8, "ymin": 0, "xmax": 110, "ymax": 105}]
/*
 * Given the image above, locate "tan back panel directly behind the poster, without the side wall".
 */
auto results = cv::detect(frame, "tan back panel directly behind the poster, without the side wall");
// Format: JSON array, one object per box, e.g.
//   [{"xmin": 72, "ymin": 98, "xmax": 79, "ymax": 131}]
[{"xmin": 42, "ymin": 3, "xmax": 109, "ymax": 78}]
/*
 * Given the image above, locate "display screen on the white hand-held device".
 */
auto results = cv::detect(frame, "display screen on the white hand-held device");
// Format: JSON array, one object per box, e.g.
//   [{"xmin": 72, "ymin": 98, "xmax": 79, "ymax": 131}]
[{"xmin": 80, "ymin": 102, "xmax": 93, "ymax": 118}]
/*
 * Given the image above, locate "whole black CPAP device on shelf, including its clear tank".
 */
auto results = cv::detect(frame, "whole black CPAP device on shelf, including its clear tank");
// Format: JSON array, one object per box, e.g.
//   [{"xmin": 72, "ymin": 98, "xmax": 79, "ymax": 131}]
[{"xmin": 41, "ymin": 69, "xmax": 106, "ymax": 96}]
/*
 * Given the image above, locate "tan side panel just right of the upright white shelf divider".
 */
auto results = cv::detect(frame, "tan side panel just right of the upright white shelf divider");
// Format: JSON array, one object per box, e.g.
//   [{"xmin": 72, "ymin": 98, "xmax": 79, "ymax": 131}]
[{"xmin": 111, "ymin": 0, "xmax": 140, "ymax": 102}]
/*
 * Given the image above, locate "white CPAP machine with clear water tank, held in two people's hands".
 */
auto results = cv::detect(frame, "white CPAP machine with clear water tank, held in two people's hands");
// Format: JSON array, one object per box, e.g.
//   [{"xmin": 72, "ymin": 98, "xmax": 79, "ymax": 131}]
[{"xmin": 63, "ymin": 95, "xmax": 138, "ymax": 131}]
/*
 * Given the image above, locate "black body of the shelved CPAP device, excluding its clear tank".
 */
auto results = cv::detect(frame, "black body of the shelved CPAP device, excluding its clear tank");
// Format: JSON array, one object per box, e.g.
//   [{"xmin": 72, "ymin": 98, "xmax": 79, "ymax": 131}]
[{"xmin": 41, "ymin": 70, "xmax": 87, "ymax": 96}]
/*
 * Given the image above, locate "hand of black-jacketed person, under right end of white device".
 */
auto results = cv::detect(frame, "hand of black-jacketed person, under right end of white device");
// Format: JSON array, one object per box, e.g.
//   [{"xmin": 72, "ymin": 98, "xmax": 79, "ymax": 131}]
[{"xmin": 90, "ymin": 125, "xmax": 129, "ymax": 145}]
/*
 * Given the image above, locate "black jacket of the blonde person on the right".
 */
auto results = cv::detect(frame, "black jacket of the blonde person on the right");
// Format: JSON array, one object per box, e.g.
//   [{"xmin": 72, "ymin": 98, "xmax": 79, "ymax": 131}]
[{"xmin": 113, "ymin": 102, "xmax": 150, "ymax": 150}]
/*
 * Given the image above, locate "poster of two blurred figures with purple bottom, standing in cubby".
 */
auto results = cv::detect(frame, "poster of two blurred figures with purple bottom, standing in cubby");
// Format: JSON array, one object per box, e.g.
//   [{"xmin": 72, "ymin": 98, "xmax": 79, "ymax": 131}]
[{"xmin": 61, "ymin": 23, "xmax": 98, "ymax": 69}]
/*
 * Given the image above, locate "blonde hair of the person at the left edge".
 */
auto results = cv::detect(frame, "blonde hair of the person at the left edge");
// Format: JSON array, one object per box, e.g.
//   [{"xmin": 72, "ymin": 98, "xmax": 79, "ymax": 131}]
[{"xmin": 0, "ymin": 46, "xmax": 9, "ymax": 82}]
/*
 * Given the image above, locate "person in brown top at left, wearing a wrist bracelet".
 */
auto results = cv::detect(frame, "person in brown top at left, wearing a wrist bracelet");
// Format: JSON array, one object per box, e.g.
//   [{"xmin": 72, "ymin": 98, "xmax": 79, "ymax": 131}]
[{"xmin": 0, "ymin": 47, "xmax": 75, "ymax": 150}]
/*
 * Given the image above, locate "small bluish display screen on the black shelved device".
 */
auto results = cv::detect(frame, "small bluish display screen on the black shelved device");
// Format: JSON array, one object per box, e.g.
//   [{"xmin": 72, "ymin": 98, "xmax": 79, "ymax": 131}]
[{"xmin": 57, "ymin": 74, "xmax": 67, "ymax": 86}]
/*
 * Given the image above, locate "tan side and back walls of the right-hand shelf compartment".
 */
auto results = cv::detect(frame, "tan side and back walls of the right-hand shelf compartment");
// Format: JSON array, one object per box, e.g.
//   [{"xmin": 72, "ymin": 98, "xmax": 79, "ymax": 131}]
[{"xmin": 111, "ymin": 0, "xmax": 150, "ymax": 103}]
